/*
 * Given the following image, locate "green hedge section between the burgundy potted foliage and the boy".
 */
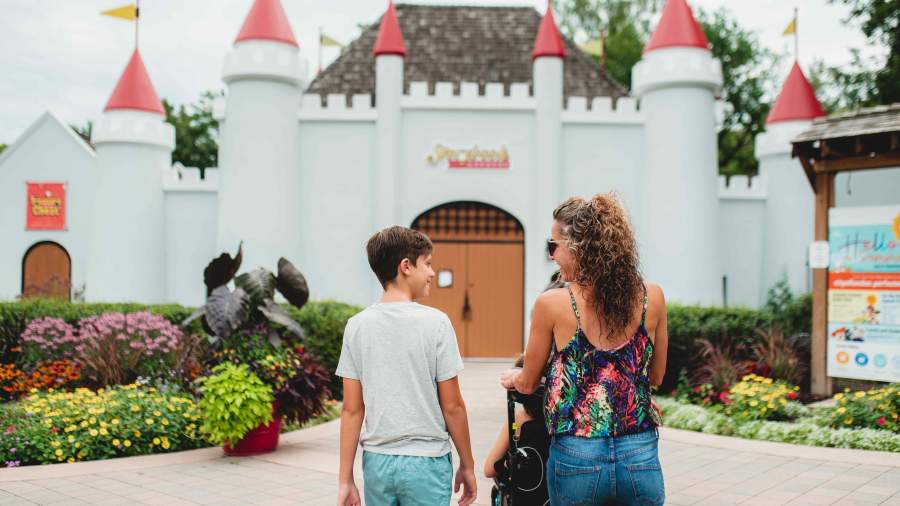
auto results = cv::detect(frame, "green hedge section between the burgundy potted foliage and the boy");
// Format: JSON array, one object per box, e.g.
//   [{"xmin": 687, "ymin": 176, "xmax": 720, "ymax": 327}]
[{"xmin": 286, "ymin": 300, "xmax": 362, "ymax": 400}]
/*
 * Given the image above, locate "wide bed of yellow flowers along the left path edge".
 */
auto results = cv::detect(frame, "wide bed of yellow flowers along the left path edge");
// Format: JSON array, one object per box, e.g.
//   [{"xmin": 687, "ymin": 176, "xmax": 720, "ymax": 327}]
[{"xmin": 0, "ymin": 385, "xmax": 206, "ymax": 467}]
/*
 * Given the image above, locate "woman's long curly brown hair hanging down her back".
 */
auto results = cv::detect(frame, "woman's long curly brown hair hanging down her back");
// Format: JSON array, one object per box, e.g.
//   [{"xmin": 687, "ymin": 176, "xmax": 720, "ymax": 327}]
[{"xmin": 553, "ymin": 193, "xmax": 644, "ymax": 339}]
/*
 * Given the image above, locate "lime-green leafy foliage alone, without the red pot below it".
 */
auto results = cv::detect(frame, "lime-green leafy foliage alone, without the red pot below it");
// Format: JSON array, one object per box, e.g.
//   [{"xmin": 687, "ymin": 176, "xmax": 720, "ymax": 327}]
[{"xmin": 197, "ymin": 362, "xmax": 275, "ymax": 445}]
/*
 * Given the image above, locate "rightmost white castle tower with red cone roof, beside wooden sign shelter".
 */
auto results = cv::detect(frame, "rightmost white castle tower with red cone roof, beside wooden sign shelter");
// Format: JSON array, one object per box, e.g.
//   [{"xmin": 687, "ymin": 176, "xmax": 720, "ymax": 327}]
[{"xmin": 756, "ymin": 62, "xmax": 825, "ymax": 303}]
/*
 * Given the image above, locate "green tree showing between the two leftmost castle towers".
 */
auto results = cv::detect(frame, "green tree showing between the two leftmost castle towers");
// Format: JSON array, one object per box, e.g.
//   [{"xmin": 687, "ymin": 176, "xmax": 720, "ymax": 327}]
[{"xmin": 163, "ymin": 91, "xmax": 225, "ymax": 172}]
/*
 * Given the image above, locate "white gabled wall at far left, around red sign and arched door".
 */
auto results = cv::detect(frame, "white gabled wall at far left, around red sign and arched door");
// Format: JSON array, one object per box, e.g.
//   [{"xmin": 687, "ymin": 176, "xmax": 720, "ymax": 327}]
[{"xmin": 0, "ymin": 112, "xmax": 95, "ymax": 300}]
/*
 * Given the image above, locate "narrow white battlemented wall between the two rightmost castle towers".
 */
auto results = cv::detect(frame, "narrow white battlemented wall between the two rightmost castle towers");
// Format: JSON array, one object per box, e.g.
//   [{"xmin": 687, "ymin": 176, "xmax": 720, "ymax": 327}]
[{"xmin": 718, "ymin": 176, "xmax": 768, "ymax": 307}]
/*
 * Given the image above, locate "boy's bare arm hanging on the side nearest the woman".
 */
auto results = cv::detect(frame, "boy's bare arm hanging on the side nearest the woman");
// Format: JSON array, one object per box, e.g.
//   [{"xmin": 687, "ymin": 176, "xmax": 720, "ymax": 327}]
[{"xmin": 438, "ymin": 376, "xmax": 476, "ymax": 506}]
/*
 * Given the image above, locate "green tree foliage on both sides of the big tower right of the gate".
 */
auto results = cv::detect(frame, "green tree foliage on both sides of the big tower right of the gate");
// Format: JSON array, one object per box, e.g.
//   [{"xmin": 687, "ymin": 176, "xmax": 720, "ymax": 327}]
[{"xmin": 558, "ymin": 0, "xmax": 778, "ymax": 175}]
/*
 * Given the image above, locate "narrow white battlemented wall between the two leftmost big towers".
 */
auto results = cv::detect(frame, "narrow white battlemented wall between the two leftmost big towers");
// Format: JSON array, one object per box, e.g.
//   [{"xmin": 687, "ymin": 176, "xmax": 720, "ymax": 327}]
[{"xmin": 163, "ymin": 168, "xmax": 219, "ymax": 306}]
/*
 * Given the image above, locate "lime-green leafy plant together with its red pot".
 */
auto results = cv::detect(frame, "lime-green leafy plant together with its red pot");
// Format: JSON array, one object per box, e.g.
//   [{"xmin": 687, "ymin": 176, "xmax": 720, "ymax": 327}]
[{"xmin": 196, "ymin": 362, "xmax": 272, "ymax": 455}]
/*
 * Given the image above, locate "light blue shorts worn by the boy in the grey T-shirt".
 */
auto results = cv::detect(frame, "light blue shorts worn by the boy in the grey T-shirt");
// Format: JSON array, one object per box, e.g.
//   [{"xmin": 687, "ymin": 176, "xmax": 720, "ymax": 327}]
[{"xmin": 363, "ymin": 452, "xmax": 453, "ymax": 506}]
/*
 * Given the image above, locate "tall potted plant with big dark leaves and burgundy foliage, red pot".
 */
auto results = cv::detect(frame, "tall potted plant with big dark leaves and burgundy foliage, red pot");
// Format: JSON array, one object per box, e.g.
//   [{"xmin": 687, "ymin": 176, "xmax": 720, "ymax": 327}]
[{"xmin": 184, "ymin": 246, "xmax": 331, "ymax": 453}]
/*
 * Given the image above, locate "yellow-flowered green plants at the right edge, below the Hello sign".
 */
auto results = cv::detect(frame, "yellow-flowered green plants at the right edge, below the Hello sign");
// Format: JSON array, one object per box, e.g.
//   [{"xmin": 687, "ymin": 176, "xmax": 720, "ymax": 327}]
[{"xmin": 830, "ymin": 383, "xmax": 900, "ymax": 432}]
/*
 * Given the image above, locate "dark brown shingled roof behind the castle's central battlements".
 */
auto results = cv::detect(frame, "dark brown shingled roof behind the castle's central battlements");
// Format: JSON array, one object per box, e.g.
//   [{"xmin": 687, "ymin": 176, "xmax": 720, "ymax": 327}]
[{"xmin": 307, "ymin": 4, "xmax": 628, "ymax": 101}]
